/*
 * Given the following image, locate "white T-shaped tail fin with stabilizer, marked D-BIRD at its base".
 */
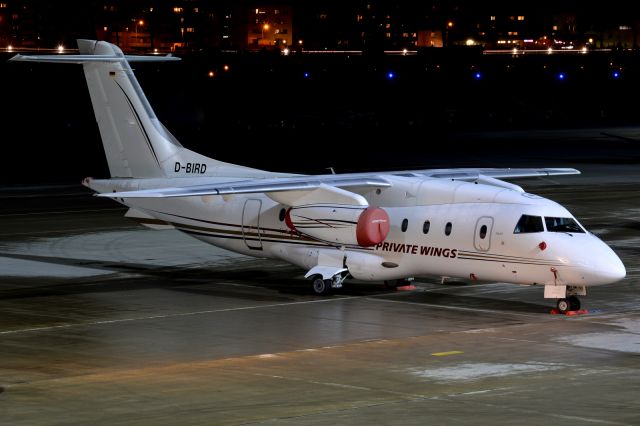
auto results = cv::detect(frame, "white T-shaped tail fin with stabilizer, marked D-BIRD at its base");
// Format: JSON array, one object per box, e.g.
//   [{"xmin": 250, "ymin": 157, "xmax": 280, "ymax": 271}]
[{"xmin": 11, "ymin": 40, "xmax": 265, "ymax": 178}]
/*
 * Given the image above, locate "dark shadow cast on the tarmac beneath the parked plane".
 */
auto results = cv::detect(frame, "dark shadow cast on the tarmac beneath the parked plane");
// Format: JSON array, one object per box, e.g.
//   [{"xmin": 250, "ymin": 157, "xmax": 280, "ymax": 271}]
[{"xmin": 0, "ymin": 253, "xmax": 549, "ymax": 313}]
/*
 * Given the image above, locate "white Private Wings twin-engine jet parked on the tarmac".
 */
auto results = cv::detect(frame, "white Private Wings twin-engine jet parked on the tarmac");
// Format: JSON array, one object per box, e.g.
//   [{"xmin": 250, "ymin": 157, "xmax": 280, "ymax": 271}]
[{"xmin": 10, "ymin": 39, "xmax": 626, "ymax": 313}]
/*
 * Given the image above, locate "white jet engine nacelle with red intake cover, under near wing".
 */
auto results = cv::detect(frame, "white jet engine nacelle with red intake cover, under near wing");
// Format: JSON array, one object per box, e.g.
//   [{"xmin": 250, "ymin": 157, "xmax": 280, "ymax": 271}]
[{"xmin": 285, "ymin": 204, "xmax": 390, "ymax": 247}]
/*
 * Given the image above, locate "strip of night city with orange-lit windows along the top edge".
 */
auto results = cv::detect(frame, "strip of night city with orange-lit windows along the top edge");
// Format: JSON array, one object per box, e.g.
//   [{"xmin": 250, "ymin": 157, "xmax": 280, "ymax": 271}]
[{"xmin": 0, "ymin": 0, "xmax": 640, "ymax": 52}]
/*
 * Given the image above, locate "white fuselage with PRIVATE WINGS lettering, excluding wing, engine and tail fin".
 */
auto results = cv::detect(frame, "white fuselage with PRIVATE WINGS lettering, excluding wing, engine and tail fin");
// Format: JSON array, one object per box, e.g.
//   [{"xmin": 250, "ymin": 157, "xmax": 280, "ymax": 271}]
[{"xmin": 89, "ymin": 176, "xmax": 626, "ymax": 286}]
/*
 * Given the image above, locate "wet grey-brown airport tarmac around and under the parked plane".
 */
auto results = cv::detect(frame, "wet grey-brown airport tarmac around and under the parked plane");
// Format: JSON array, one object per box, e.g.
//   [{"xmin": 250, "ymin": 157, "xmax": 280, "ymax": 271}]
[{"xmin": 0, "ymin": 162, "xmax": 640, "ymax": 425}]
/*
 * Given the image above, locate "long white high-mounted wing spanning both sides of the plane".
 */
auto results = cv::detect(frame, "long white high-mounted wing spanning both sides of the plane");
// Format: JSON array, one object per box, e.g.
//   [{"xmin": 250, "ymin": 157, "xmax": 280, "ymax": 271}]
[{"xmin": 96, "ymin": 168, "xmax": 580, "ymax": 198}]
